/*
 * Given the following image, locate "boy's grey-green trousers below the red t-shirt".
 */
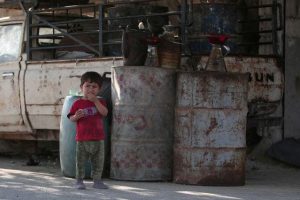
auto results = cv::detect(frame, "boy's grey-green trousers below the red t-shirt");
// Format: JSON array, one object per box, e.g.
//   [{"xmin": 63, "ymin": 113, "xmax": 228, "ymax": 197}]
[{"xmin": 76, "ymin": 140, "xmax": 104, "ymax": 180}]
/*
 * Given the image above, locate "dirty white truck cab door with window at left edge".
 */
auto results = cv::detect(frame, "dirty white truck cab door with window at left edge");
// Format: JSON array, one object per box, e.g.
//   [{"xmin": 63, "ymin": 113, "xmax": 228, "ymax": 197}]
[{"xmin": 0, "ymin": 21, "xmax": 30, "ymax": 135}]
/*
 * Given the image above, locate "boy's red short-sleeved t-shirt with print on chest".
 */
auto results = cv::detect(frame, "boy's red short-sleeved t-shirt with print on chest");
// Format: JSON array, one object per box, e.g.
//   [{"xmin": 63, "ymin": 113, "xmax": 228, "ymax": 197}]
[{"xmin": 68, "ymin": 99, "xmax": 106, "ymax": 141}]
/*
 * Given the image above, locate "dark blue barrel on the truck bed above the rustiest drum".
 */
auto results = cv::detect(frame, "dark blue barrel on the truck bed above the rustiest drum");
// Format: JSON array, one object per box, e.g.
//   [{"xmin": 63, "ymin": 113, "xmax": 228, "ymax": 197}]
[{"xmin": 189, "ymin": 0, "xmax": 244, "ymax": 54}]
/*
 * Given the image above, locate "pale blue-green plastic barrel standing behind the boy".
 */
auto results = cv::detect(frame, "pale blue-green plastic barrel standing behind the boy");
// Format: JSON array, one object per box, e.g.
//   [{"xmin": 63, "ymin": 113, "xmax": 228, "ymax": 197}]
[{"xmin": 59, "ymin": 96, "xmax": 109, "ymax": 178}]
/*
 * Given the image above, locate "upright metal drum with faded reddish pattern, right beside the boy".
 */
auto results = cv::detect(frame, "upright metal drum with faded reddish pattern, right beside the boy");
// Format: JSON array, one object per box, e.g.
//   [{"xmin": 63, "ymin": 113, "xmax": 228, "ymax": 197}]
[{"xmin": 110, "ymin": 66, "xmax": 175, "ymax": 181}]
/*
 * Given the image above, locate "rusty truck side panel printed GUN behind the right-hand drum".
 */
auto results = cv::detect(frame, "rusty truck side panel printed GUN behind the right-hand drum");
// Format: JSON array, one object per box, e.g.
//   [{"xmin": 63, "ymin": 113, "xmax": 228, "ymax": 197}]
[{"xmin": 199, "ymin": 56, "xmax": 284, "ymax": 103}]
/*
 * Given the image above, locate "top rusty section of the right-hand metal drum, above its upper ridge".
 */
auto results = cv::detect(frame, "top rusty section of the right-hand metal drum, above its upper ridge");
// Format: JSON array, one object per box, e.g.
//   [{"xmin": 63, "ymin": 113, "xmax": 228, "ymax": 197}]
[{"xmin": 177, "ymin": 72, "xmax": 248, "ymax": 109}]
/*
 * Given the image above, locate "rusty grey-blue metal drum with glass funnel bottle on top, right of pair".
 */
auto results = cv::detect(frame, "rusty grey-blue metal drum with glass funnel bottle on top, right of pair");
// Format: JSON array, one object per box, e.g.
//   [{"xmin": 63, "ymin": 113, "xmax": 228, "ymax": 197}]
[{"xmin": 174, "ymin": 72, "xmax": 248, "ymax": 186}]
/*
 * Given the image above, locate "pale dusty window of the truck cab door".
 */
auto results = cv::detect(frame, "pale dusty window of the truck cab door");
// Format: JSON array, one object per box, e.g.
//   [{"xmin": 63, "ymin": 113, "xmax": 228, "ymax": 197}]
[{"xmin": 0, "ymin": 24, "xmax": 22, "ymax": 63}]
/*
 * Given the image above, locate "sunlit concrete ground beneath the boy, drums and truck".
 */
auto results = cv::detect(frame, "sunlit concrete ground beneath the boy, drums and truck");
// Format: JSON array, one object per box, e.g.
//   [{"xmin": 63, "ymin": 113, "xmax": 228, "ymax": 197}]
[{"xmin": 0, "ymin": 156, "xmax": 300, "ymax": 200}]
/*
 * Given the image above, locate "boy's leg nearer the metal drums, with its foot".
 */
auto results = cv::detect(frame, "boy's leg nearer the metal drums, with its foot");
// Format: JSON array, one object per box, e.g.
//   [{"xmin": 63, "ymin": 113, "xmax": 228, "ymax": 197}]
[{"xmin": 91, "ymin": 140, "xmax": 108, "ymax": 189}]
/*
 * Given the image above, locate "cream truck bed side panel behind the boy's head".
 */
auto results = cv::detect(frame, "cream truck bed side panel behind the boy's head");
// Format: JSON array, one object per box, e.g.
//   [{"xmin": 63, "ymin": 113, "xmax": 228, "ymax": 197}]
[{"xmin": 25, "ymin": 58, "xmax": 122, "ymax": 130}]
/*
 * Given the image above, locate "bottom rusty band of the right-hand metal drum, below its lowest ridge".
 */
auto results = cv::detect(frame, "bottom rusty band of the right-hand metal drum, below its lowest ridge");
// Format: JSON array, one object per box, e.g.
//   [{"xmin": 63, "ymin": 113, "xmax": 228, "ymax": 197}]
[{"xmin": 174, "ymin": 148, "xmax": 246, "ymax": 186}]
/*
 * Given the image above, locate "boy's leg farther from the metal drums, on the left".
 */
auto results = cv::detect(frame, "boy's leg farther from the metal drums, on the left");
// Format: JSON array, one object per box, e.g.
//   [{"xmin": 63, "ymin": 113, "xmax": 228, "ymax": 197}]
[{"xmin": 76, "ymin": 142, "xmax": 87, "ymax": 189}]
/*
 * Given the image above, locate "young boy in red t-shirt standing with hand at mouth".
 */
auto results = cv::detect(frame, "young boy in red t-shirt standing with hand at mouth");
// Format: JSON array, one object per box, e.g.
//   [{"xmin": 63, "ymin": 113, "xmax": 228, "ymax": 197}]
[{"xmin": 68, "ymin": 72, "xmax": 108, "ymax": 189}]
